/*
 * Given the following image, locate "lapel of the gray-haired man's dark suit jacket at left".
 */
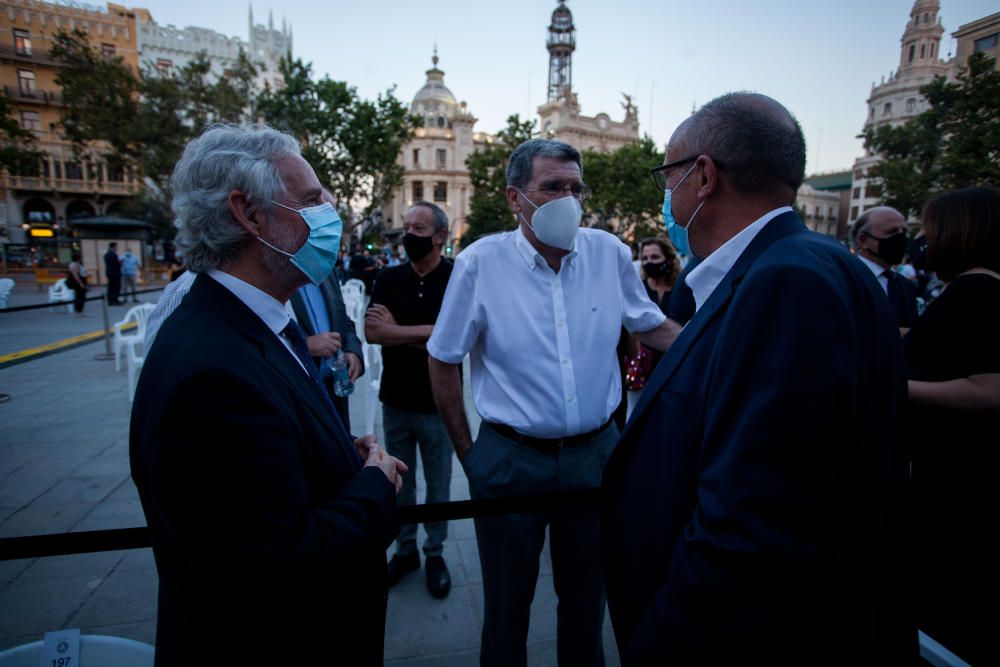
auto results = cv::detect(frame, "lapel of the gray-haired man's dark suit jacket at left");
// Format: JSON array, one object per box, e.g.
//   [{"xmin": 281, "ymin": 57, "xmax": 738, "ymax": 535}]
[{"xmin": 191, "ymin": 276, "xmax": 358, "ymax": 467}]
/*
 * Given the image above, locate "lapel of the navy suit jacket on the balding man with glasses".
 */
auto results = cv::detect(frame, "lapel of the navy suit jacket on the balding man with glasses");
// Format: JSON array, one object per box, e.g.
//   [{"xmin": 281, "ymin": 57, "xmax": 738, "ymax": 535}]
[{"xmin": 622, "ymin": 213, "xmax": 805, "ymax": 442}]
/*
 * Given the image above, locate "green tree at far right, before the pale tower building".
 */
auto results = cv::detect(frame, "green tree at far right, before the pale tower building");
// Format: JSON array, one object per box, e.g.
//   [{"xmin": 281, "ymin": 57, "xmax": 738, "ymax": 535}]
[{"xmin": 863, "ymin": 53, "xmax": 1000, "ymax": 215}]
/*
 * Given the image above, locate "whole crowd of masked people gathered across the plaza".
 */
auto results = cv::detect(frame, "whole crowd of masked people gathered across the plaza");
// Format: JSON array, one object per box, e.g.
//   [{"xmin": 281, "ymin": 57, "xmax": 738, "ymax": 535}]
[{"xmin": 130, "ymin": 93, "xmax": 1000, "ymax": 666}]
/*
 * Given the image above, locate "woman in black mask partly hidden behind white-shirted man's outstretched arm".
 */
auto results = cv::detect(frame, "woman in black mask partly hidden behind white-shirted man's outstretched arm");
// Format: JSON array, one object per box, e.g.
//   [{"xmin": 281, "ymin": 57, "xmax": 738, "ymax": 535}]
[{"xmin": 624, "ymin": 238, "xmax": 681, "ymax": 415}]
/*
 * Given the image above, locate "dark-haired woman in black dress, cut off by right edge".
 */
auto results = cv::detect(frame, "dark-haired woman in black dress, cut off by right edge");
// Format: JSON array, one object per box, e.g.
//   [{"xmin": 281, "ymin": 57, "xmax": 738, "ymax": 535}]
[{"xmin": 903, "ymin": 187, "xmax": 1000, "ymax": 665}]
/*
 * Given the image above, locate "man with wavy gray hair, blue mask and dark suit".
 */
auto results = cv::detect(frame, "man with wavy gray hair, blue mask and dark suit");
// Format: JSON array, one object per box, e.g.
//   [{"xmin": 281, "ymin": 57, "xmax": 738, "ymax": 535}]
[{"xmin": 129, "ymin": 126, "xmax": 406, "ymax": 665}]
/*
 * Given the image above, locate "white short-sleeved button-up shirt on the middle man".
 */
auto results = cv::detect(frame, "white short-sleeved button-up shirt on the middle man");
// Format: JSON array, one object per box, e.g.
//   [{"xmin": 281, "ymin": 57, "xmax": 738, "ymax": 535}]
[{"xmin": 427, "ymin": 228, "xmax": 666, "ymax": 438}]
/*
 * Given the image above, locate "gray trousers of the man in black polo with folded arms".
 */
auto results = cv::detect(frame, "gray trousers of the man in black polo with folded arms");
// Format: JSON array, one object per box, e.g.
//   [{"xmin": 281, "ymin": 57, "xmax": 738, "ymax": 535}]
[{"xmin": 382, "ymin": 405, "xmax": 454, "ymax": 556}]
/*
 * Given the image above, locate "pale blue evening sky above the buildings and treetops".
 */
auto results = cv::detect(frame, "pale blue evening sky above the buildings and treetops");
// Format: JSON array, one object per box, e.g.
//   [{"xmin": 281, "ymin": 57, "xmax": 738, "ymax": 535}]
[{"xmin": 134, "ymin": 0, "xmax": 998, "ymax": 173}]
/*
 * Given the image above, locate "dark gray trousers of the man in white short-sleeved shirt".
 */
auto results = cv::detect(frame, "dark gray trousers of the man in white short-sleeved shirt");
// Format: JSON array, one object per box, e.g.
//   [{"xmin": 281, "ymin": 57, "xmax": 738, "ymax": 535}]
[{"xmin": 462, "ymin": 422, "xmax": 618, "ymax": 667}]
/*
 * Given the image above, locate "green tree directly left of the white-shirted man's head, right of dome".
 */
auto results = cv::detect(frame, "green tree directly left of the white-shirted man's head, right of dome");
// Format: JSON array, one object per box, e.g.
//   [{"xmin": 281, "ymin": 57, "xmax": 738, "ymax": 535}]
[{"xmin": 462, "ymin": 114, "xmax": 535, "ymax": 248}]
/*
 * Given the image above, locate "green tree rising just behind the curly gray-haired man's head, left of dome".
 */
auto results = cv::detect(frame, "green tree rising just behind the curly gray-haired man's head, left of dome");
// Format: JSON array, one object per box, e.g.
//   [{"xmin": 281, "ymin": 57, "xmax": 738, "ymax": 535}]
[{"xmin": 257, "ymin": 59, "xmax": 416, "ymax": 227}]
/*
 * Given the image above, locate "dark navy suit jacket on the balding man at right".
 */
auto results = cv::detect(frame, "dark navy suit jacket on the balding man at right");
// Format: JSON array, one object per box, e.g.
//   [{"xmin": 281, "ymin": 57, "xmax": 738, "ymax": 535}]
[{"xmin": 601, "ymin": 213, "xmax": 916, "ymax": 665}]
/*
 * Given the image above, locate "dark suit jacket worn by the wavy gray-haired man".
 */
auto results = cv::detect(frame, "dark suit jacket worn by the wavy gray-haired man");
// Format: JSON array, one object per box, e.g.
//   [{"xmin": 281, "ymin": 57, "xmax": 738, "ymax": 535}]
[{"xmin": 129, "ymin": 275, "xmax": 399, "ymax": 665}]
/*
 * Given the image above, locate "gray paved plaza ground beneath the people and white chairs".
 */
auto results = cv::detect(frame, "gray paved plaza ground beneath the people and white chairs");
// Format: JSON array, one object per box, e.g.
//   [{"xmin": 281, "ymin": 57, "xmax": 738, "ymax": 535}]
[{"xmin": 0, "ymin": 276, "xmax": 618, "ymax": 666}]
